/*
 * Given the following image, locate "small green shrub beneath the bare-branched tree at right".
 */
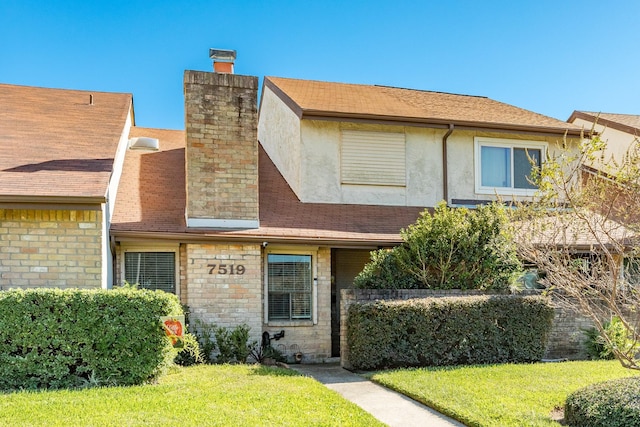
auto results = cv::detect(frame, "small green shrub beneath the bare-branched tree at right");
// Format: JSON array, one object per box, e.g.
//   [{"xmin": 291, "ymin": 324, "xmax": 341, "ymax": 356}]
[{"xmin": 584, "ymin": 316, "xmax": 638, "ymax": 360}]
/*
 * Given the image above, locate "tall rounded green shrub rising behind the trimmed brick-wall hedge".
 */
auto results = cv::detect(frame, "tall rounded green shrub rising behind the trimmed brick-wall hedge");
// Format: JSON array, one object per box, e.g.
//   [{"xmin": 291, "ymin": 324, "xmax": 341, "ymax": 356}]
[{"xmin": 354, "ymin": 202, "xmax": 521, "ymax": 290}]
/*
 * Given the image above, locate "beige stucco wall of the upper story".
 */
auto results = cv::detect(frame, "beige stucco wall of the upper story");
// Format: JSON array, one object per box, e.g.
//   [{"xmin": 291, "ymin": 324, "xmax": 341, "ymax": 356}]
[{"xmin": 261, "ymin": 98, "xmax": 577, "ymax": 206}]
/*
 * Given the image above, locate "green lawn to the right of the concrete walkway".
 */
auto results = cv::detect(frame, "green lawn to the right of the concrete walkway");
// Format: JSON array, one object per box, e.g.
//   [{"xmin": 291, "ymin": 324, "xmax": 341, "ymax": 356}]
[{"xmin": 370, "ymin": 361, "xmax": 637, "ymax": 427}]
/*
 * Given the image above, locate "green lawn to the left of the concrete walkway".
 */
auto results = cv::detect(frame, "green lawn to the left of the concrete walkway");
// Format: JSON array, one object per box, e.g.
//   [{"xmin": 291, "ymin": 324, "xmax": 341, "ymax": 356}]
[{"xmin": 0, "ymin": 365, "xmax": 382, "ymax": 426}]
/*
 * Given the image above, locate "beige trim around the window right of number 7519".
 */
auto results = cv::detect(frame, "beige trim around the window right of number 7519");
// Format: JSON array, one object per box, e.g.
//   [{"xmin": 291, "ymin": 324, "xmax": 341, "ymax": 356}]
[{"xmin": 263, "ymin": 246, "xmax": 318, "ymax": 326}]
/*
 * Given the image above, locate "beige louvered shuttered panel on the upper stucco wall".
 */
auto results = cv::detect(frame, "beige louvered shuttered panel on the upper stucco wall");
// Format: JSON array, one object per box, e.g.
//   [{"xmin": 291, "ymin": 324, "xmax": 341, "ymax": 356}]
[{"xmin": 340, "ymin": 130, "xmax": 406, "ymax": 187}]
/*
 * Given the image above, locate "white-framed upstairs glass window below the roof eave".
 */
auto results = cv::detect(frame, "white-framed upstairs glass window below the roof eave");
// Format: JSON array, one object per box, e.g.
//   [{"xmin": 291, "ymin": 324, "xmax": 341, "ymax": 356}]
[{"xmin": 475, "ymin": 137, "xmax": 546, "ymax": 196}]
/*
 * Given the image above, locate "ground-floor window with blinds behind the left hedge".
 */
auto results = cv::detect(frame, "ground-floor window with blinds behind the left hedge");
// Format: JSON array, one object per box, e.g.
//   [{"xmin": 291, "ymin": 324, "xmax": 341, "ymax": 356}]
[{"xmin": 124, "ymin": 251, "xmax": 176, "ymax": 293}]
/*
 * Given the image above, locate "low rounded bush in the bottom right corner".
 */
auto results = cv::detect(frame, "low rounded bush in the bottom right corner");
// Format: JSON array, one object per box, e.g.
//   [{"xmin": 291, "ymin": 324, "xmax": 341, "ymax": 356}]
[{"xmin": 564, "ymin": 377, "xmax": 640, "ymax": 427}]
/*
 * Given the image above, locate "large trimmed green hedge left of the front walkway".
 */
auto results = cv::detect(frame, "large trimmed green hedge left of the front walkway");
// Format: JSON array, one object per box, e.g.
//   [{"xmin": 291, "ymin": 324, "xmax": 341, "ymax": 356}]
[{"xmin": 0, "ymin": 289, "xmax": 182, "ymax": 390}]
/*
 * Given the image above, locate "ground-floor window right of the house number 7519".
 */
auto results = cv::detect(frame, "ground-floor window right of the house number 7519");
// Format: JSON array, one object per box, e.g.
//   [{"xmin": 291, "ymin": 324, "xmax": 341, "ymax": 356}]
[{"xmin": 267, "ymin": 253, "xmax": 313, "ymax": 321}]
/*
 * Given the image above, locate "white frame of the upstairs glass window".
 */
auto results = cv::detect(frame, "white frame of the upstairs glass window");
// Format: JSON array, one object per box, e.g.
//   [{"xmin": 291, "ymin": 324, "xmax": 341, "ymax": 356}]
[{"xmin": 473, "ymin": 136, "xmax": 548, "ymax": 196}]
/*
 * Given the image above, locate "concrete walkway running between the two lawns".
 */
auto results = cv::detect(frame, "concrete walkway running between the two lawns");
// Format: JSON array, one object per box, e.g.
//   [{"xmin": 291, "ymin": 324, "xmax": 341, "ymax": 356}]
[{"xmin": 290, "ymin": 363, "xmax": 464, "ymax": 427}]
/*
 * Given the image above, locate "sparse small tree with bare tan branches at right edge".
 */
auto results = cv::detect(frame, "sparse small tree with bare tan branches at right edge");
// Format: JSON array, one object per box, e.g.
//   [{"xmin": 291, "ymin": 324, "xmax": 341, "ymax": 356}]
[{"xmin": 513, "ymin": 130, "xmax": 640, "ymax": 369}]
